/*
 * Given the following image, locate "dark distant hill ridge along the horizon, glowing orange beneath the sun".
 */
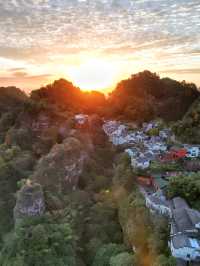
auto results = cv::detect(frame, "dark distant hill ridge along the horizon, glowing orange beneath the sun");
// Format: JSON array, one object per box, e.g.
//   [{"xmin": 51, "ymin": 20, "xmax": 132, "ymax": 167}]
[{"xmin": 0, "ymin": 70, "xmax": 200, "ymax": 123}]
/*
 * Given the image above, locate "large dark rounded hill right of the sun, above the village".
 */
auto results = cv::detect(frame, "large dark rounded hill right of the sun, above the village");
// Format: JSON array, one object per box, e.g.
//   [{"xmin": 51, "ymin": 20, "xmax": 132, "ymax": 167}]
[{"xmin": 109, "ymin": 71, "xmax": 199, "ymax": 122}]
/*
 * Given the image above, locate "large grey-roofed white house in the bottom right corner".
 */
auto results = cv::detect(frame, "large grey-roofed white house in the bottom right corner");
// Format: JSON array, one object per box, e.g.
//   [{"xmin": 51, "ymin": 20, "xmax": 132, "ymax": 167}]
[{"xmin": 170, "ymin": 197, "xmax": 200, "ymax": 261}]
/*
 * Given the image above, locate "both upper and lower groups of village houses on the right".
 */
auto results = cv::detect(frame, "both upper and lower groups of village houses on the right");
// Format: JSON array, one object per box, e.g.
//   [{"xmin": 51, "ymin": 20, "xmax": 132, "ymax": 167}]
[{"xmin": 103, "ymin": 121, "xmax": 200, "ymax": 262}]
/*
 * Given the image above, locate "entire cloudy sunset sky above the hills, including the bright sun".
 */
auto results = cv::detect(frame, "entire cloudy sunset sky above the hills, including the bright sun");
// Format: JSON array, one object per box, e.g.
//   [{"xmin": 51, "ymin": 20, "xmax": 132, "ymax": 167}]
[{"xmin": 0, "ymin": 0, "xmax": 200, "ymax": 91}]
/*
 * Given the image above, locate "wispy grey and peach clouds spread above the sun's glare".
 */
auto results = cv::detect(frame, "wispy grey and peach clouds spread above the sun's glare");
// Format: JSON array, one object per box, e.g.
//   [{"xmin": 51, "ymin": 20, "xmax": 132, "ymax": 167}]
[{"xmin": 0, "ymin": 0, "xmax": 200, "ymax": 89}]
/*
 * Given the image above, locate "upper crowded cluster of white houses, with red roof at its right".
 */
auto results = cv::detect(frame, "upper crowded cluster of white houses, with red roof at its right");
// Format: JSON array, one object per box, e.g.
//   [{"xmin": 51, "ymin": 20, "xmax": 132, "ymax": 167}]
[{"xmin": 103, "ymin": 121, "xmax": 200, "ymax": 169}]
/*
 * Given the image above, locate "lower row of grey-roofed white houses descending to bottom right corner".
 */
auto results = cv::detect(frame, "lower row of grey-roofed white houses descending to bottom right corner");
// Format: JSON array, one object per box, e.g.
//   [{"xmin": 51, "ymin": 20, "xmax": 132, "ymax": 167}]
[{"xmin": 140, "ymin": 187, "xmax": 200, "ymax": 262}]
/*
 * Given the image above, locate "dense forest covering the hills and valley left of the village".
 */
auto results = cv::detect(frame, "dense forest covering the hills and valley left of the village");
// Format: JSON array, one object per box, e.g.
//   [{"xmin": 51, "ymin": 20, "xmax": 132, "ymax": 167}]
[{"xmin": 0, "ymin": 71, "xmax": 199, "ymax": 266}]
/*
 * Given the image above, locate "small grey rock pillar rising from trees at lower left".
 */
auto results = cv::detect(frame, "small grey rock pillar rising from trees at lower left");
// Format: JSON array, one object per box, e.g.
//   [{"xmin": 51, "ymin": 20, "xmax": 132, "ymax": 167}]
[{"xmin": 14, "ymin": 183, "xmax": 45, "ymax": 221}]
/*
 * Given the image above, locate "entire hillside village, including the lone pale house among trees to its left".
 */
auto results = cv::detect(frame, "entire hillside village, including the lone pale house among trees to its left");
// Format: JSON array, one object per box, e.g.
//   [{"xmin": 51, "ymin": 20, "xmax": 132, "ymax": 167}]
[{"xmin": 75, "ymin": 114, "xmax": 200, "ymax": 265}]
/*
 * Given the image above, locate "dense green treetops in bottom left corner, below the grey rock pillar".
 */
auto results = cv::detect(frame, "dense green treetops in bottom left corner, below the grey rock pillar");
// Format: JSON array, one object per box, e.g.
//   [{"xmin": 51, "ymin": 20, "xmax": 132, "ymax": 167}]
[{"xmin": 0, "ymin": 217, "xmax": 76, "ymax": 266}]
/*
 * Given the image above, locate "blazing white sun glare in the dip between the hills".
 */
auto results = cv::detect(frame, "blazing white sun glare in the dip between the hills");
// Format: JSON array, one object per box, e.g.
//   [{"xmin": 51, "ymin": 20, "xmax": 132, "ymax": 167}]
[{"xmin": 67, "ymin": 59, "xmax": 119, "ymax": 92}]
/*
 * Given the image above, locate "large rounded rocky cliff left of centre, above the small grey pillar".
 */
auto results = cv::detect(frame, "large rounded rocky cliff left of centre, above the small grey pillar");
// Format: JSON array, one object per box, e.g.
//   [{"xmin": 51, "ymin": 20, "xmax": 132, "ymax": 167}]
[{"xmin": 33, "ymin": 137, "xmax": 88, "ymax": 192}]
